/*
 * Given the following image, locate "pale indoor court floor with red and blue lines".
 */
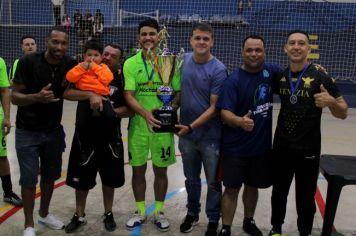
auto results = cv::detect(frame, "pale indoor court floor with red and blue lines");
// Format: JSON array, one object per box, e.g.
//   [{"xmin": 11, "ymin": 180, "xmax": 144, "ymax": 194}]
[{"xmin": 0, "ymin": 101, "xmax": 356, "ymax": 236}]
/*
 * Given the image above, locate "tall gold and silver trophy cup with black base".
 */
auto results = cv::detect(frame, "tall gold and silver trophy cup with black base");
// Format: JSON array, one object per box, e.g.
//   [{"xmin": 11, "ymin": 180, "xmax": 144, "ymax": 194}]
[{"xmin": 150, "ymin": 27, "xmax": 184, "ymax": 133}]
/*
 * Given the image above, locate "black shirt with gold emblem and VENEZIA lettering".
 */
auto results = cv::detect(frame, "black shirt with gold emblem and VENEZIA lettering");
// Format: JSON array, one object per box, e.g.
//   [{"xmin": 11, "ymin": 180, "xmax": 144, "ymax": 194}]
[{"xmin": 273, "ymin": 64, "xmax": 341, "ymax": 156}]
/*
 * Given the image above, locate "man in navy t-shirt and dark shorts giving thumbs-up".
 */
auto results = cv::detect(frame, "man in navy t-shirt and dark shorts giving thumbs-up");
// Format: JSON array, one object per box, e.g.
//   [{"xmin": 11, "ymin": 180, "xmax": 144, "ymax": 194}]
[{"xmin": 217, "ymin": 35, "xmax": 280, "ymax": 236}]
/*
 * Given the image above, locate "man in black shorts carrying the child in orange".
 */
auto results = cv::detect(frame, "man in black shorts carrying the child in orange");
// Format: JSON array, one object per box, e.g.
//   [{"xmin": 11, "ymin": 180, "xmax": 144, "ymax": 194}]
[{"xmin": 64, "ymin": 43, "xmax": 132, "ymax": 233}]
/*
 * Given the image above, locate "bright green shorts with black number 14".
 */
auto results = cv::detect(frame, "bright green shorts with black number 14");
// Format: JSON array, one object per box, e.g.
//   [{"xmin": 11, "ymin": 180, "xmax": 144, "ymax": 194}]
[{"xmin": 128, "ymin": 129, "xmax": 176, "ymax": 167}]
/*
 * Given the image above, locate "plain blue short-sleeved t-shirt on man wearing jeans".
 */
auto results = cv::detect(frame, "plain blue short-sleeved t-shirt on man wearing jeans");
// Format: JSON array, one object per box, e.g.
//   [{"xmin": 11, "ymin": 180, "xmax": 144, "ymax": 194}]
[{"xmin": 180, "ymin": 53, "xmax": 227, "ymax": 140}]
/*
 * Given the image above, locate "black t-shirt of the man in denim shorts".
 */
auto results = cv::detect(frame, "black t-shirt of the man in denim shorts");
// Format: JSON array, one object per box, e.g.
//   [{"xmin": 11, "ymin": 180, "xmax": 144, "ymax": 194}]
[{"xmin": 14, "ymin": 52, "xmax": 77, "ymax": 131}]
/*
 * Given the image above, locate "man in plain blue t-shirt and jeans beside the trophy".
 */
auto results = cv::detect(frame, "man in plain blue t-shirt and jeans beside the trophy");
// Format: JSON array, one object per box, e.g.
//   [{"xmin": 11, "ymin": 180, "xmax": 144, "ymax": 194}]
[{"xmin": 176, "ymin": 23, "xmax": 227, "ymax": 236}]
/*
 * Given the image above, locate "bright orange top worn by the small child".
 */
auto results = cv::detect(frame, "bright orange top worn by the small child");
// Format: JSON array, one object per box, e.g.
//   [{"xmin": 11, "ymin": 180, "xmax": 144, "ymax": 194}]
[{"xmin": 66, "ymin": 63, "xmax": 114, "ymax": 96}]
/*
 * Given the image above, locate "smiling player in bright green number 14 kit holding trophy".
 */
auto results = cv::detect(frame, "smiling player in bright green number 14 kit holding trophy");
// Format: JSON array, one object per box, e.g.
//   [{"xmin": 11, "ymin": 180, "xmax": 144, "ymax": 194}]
[{"xmin": 124, "ymin": 19, "xmax": 180, "ymax": 231}]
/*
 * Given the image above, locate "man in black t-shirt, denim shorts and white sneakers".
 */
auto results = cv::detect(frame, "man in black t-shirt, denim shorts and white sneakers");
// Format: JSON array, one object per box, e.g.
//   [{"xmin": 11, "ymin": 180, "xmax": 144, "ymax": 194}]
[{"xmin": 11, "ymin": 26, "xmax": 76, "ymax": 236}]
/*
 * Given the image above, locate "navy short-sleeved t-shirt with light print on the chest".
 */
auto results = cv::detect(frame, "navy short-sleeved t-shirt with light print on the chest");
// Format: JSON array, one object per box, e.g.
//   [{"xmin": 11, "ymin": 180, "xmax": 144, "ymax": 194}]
[{"xmin": 217, "ymin": 64, "xmax": 280, "ymax": 158}]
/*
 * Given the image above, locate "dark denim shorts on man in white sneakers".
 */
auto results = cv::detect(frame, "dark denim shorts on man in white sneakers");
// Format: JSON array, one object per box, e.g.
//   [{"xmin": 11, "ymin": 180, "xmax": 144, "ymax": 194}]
[{"xmin": 15, "ymin": 127, "xmax": 64, "ymax": 188}]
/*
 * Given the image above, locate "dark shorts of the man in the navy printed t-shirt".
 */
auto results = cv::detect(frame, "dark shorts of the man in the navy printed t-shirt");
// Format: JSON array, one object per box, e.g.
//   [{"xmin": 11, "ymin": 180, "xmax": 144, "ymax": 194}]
[{"xmin": 222, "ymin": 152, "xmax": 272, "ymax": 188}]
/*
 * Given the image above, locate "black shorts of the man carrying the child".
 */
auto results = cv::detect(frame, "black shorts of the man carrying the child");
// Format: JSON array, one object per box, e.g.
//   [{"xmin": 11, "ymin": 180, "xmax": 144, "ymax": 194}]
[{"xmin": 66, "ymin": 129, "xmax": 125, "ymax": 190}]
